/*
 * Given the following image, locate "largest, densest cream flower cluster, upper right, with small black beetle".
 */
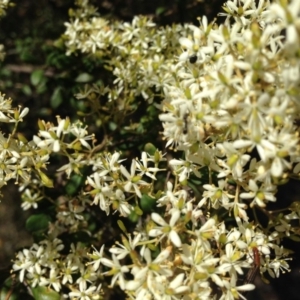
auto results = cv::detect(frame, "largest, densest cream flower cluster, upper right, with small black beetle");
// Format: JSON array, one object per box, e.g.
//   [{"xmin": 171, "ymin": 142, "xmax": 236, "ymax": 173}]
[{"xmin": 160, "ymin": 1, "xmax": 300, "ymax": 211}]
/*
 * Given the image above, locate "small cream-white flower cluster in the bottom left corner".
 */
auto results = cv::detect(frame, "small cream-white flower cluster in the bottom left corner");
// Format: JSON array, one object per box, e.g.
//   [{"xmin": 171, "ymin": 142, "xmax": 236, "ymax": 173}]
[{"xmin": 13, "ymin": 239, "xmax": 101, "ymax": 299}]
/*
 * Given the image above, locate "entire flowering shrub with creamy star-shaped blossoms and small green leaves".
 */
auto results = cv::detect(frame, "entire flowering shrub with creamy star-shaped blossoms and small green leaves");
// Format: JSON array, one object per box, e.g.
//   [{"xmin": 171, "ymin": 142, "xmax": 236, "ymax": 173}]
[{"xmin": 0, "ymin": 0, "xmax": 300, "ymax": 300}]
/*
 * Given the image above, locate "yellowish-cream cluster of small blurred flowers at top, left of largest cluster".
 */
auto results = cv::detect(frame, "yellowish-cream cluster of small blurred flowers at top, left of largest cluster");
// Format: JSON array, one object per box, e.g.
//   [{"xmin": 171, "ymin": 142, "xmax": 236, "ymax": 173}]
[{"xmin": 63, "ymin": 3, "xmax": 187, "ymax": 103}]
